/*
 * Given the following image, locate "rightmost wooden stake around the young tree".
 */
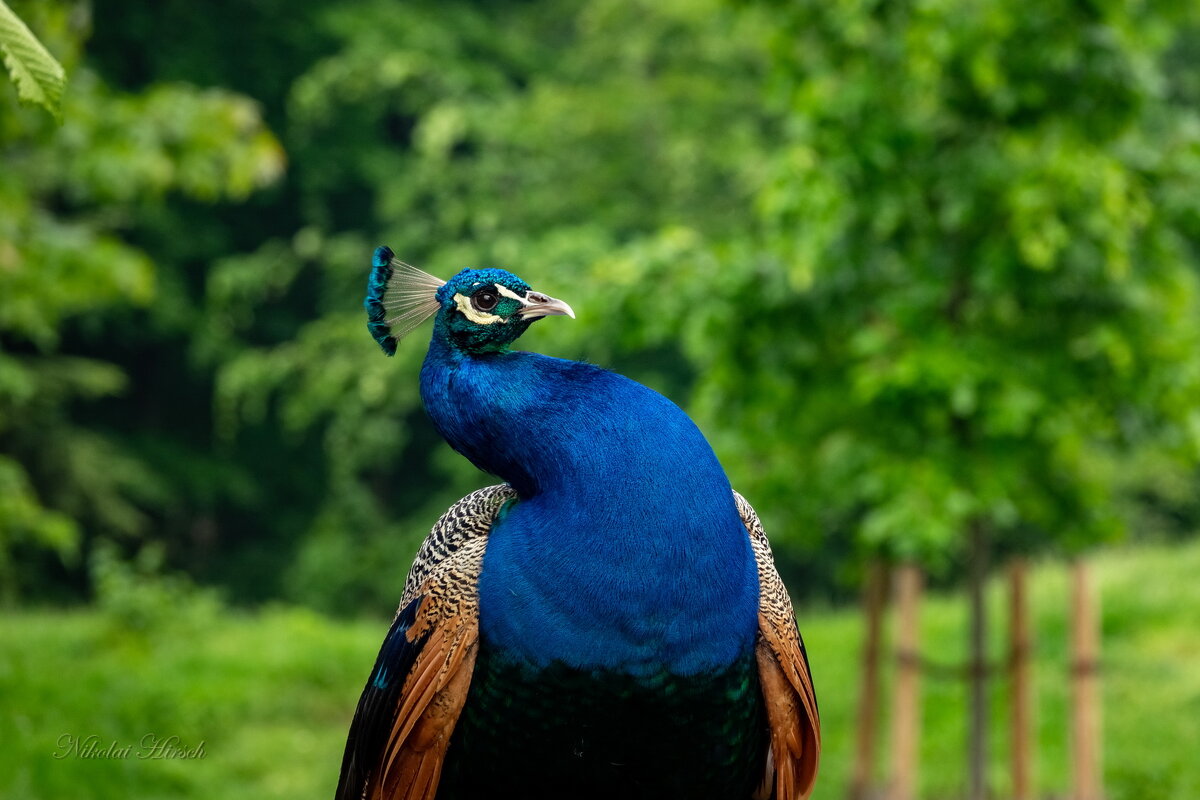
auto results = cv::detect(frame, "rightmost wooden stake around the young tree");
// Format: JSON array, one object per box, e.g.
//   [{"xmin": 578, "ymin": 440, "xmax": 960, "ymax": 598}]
[{"xmin": 1070, "ymin": 559, "xmax": 1104, "ymax": 800}]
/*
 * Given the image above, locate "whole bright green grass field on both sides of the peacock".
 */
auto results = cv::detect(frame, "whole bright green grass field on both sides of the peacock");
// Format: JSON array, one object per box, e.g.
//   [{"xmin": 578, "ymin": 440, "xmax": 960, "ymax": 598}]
[{"xmin": 0, "ymin": 543, "xmax": 1200, "ymax": 800}]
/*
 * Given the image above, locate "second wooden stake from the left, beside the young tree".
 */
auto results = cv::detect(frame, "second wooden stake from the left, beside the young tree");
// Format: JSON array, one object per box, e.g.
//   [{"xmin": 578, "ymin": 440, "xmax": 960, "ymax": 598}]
[{"xmin": 889, "ymin": 564, "xmax": 920, "ymax": 800}]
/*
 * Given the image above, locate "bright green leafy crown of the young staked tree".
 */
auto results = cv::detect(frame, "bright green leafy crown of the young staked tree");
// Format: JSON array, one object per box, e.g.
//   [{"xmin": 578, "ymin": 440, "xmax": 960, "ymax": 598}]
[{"xmin": 689, "ymin": 2, "xmax": 1200, "ymax": 564}]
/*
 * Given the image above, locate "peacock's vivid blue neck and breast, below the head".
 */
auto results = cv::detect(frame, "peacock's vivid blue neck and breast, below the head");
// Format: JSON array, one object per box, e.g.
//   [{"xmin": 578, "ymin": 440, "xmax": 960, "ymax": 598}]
[{"xmin": 421, "ymin": 331, "xmax": 758, "ymax": 674}]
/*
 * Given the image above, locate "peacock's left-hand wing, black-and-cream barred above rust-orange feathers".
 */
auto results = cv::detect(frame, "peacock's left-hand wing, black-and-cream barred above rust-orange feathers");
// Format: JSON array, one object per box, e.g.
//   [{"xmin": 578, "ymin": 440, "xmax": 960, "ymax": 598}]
[{"xmin": 335, "ymin": 485, "xmax": 516, "ymax": 800}]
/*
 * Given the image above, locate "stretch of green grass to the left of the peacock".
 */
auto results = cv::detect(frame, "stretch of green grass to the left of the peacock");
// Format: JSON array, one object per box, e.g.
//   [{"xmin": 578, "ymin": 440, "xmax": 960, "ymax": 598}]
[{"xmin": 0, "ymin": 609, "xmax": 386, "ymax": 800}]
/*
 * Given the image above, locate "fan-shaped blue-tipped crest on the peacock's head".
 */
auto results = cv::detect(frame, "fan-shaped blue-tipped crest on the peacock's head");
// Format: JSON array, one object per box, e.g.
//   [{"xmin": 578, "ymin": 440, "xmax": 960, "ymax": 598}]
[{"xmin": 362, "ymin": 247, "xmax": 445, "ymax": 355}]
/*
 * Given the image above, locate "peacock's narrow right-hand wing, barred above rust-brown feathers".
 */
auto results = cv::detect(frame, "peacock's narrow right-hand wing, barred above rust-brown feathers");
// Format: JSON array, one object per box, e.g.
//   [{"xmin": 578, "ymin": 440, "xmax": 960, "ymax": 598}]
[{"xmin": 733, "ymin": 492, "xmax": 821, "ymax": 800}]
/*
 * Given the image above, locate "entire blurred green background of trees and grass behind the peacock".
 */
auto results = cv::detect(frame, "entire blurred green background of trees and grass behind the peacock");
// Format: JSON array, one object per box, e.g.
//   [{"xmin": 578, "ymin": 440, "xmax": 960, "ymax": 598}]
[{"xmin": 0, "ymin": 0, "xmax": 1200, "ymax": 800}]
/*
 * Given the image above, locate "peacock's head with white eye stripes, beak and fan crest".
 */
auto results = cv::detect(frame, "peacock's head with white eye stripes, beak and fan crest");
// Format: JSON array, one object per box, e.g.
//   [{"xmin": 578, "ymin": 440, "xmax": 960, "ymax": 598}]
[{"xmin": 364, "ymin": 247, "xmax": 575, "ymax": 355}]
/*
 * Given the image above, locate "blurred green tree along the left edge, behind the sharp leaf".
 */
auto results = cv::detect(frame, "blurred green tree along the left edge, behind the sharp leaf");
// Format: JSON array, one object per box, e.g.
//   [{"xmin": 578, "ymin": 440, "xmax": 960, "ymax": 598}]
[{"xmin": 0, "ymin": 2, "xmax": 283, "ymax": 597}]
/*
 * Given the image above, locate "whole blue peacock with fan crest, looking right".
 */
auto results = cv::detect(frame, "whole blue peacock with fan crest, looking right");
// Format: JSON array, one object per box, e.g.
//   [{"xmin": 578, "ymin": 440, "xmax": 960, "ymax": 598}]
[{"xmin": 336, "ymin": 247, "xmax": 821, "ymax": 800}]
